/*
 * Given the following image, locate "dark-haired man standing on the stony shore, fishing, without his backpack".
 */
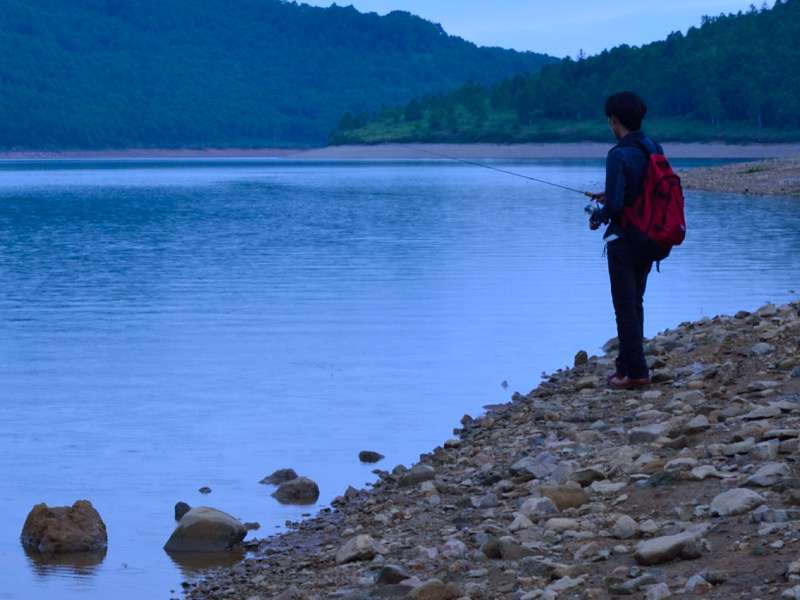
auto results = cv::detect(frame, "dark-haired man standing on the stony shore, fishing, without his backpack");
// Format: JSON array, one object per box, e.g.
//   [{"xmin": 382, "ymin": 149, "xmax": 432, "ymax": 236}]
[{"xmin": 589, "ymin": 92, "xmax": 662, "ymax": 389}]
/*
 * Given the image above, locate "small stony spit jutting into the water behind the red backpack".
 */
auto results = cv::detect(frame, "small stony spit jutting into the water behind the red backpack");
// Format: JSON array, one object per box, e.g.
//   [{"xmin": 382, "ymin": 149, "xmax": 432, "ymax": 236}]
[{"xmin": 678, "ymin": 158, "xmax": 800, "ymax": 196}]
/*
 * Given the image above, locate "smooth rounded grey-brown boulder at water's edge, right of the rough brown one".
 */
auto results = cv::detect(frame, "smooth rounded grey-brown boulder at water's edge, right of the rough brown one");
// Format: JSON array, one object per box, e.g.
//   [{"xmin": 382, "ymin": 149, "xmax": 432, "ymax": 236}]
[{"xmin": 164, "ymin": 506, "xmax": 247, "ymax": 552}]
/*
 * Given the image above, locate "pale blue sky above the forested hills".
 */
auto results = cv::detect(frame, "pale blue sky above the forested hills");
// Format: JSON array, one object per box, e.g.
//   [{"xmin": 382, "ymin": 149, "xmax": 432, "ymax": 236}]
[{"xmin": 298, "ymin": 0, "xmax": 764, "ymax": 58}]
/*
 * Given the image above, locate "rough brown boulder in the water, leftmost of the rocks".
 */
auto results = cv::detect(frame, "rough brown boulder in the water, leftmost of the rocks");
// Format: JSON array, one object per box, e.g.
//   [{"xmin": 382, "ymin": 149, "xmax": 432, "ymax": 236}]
[{"xmin": 20, "ymin": 500, "xmax": 108, "ymax": 554}]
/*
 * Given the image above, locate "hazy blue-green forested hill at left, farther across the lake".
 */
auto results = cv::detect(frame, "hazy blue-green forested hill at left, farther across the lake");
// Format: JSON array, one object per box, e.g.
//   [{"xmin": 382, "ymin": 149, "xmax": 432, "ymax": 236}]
[{"xmin": 0, "ymin": 0, "xmax": 556, "ymax": 148}]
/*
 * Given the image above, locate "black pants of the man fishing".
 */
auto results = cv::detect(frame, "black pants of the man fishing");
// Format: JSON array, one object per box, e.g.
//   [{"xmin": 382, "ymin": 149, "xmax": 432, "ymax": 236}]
[{"xmin": 606, "ymin": 239, "xmax": 653, "ymax": 379}]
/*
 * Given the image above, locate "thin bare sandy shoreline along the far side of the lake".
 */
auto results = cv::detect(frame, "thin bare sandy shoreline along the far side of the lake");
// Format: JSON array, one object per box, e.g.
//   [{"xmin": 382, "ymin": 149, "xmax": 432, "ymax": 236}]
[{"xmin": 0, "ymin": 140, "xmax": 800, "ymax": 160}]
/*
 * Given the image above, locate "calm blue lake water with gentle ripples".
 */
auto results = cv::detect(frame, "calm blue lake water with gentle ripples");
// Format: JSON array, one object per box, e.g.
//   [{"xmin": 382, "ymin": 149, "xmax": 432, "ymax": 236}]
[{"xmin": 0, "ymin": 159, "xmax": 800, "ymax": 600}]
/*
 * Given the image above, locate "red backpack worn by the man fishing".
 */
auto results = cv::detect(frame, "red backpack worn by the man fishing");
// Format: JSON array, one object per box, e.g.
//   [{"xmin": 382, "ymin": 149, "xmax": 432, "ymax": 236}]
[{"xmin": 622, "ymin": 140, "xmax": 686, "ymax": 261}]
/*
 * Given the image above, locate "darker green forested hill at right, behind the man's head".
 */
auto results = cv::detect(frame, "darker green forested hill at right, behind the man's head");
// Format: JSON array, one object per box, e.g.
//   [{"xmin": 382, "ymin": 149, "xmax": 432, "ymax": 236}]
[{"xmin": 331, "ymin": 0, "xmax": 800, "ymax": 143}]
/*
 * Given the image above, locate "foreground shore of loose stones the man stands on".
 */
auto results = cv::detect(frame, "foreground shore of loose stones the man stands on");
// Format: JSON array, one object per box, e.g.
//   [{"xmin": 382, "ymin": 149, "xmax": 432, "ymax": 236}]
[{"xmin": 178, "ymin": 301, "xmax": 800, "ymax": 600}]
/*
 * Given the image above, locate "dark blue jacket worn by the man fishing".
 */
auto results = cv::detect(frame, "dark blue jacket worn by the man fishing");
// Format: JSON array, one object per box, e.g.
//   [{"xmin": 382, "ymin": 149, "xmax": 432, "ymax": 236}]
[{"xmin": 595, "ymin": 131, "xmax": 662, "ymax": 241}]
